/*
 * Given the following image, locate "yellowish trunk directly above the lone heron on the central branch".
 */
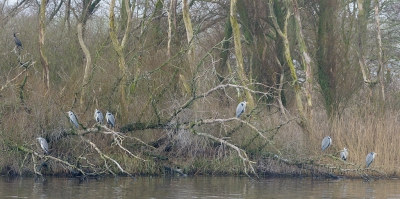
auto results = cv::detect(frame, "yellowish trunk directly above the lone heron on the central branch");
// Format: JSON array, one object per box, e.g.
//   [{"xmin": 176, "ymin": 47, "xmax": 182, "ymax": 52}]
[{"xmin": 230, "ymin": 0, "xmax": 254, "ymax": 107}]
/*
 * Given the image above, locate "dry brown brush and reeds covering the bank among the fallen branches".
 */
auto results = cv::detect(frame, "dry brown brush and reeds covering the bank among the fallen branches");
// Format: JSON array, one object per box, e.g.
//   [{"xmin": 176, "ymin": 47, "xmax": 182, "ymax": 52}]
[{"xmin": 0, "ymin": 12, "xmax": 400, "ymax": 176}]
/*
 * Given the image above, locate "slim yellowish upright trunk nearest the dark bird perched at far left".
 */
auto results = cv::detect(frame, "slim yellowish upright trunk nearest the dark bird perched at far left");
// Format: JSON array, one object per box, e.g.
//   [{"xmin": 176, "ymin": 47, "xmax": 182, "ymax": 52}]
[{"xmin": 39, "ymin": 0, "xmax": 50, "ymax": 91}]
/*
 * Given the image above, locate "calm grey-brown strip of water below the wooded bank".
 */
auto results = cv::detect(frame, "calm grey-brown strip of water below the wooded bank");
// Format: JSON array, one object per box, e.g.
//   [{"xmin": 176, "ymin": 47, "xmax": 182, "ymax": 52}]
[{"xmin": 0, "ymin": 177, "xmax": 400, "ymax": 199}]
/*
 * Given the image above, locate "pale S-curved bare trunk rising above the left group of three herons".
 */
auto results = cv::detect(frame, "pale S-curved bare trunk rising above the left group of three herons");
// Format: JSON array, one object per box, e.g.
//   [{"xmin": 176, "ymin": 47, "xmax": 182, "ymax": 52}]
[{"xmin": 77, "ymin": 22, "xmax": 92, "ymax": 106}]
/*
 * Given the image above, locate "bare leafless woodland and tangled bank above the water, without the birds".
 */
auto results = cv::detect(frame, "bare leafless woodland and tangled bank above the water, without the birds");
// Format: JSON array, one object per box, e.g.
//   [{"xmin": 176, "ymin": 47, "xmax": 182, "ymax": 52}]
[{"xmin": 0, "ymin": 0, "xmax": 400, "ymax": 176}]
